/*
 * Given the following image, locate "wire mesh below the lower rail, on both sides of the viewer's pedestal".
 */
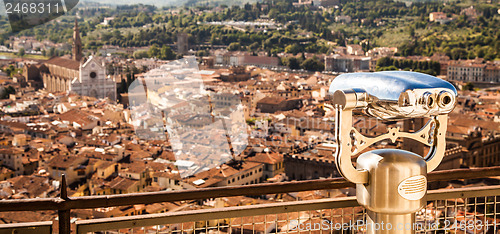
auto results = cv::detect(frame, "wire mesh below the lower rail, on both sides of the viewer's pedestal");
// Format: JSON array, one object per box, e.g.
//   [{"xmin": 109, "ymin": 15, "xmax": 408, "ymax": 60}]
[{"xmin": 89, "ymin": 196, "xmax": 500, "ymax": 234}]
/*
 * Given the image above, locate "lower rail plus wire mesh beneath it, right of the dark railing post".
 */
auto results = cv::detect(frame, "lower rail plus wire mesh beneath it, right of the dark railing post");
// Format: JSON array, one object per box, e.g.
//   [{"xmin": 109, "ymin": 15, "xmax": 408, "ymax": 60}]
[{"xmin": 77, "ymin": 186, "xmax": 500, "ymax": 234}]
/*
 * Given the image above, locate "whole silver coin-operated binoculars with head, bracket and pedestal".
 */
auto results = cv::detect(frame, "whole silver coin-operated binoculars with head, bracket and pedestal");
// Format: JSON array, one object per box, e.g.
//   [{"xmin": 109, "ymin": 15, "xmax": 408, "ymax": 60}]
[{"xmin": 329, "ymin": 71, "xmax": 457, "ymax": 233}]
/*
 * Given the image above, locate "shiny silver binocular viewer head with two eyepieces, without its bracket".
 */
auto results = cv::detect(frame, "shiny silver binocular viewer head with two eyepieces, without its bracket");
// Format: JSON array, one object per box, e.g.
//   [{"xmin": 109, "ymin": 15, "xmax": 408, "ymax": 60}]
[{"xmin": 329, "ymin": 71, "xmax": 457, "ymax": 120}]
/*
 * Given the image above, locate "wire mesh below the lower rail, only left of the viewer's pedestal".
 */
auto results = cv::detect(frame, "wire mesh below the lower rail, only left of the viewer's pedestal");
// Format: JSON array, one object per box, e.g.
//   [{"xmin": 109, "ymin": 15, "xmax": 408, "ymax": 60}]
[{"xmin": 87, "ymin": 207, "xmax": 366, "ymax": 234}]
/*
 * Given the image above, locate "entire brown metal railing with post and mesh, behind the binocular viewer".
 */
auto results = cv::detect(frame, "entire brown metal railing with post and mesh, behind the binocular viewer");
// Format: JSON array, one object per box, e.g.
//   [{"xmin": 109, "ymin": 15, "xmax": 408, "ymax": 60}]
[{"xmin": 0, "ymin": 167, "xmax": 500, "ymax": 233}]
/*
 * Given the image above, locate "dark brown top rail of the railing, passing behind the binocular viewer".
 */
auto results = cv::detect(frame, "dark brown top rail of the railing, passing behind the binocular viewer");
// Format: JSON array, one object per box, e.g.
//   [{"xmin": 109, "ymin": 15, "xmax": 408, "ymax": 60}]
[{"xmin": 0, "ymin": 166, "xmax": 500, "ymax": 212}]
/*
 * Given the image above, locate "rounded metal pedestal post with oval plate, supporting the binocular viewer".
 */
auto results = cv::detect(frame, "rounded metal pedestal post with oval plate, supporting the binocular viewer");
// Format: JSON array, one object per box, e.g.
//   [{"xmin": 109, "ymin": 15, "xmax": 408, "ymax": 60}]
[{"xmin": 356, "ymin": 149, "xmax": 427, "ymax": 234}]
